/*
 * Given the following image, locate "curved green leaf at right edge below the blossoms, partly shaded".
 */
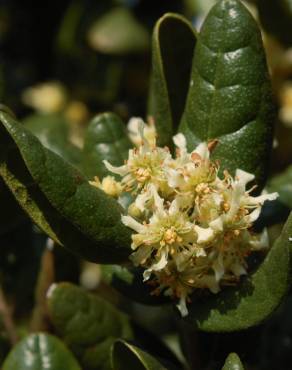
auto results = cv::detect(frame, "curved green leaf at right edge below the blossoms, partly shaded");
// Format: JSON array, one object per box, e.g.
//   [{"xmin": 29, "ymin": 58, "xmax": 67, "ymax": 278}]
[{"xmin": 185, "ymin": 213, "xmax": 292, "ymax": 332}]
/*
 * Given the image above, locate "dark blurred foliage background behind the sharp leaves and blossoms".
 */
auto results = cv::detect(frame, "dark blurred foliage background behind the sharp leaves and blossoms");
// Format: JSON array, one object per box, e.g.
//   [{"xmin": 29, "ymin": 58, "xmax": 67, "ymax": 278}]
[{"xmin": 0, "ymin": 0, "xmax": 292, "ymax": 370}]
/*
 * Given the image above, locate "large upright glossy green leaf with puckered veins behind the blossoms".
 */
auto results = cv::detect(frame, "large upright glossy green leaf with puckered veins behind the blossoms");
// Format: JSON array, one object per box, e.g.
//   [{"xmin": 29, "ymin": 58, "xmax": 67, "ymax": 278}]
[{"xmin": 180, "ymin": 0, "xmax": 274, "ymax": 189}]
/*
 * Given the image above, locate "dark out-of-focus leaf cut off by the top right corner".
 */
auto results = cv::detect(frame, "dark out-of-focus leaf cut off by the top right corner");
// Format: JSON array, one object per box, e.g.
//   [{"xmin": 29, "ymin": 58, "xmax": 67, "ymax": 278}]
[{"xmin": 256, "ymin": 0, "xmax": 292, "ymax": 46}]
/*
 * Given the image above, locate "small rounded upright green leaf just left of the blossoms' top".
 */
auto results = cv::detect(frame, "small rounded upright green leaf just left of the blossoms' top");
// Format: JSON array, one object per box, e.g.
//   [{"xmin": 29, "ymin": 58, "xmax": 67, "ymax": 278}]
[{"xmin": 82, "ymin": 113, "xmax": 133, "ymax": 178}]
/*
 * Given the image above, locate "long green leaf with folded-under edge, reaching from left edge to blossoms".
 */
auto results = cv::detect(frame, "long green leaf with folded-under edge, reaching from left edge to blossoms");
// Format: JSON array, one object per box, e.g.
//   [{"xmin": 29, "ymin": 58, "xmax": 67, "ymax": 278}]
[{"xmin": 0, "ymin": 112, "xmax": 130, "ymax": 263}]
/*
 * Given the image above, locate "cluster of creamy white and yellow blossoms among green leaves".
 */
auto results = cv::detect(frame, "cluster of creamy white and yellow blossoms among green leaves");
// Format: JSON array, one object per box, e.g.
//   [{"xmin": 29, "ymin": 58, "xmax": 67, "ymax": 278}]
[{"xmin": 92, "ymin": 119, "xmax": 277, "ymax": 316}]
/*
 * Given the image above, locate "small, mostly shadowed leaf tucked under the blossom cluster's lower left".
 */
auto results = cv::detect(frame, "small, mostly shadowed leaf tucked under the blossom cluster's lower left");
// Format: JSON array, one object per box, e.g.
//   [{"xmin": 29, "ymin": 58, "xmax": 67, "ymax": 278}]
[{"xmin": 101, "ymin": 265, "xmax": 171, "ymax": 305}]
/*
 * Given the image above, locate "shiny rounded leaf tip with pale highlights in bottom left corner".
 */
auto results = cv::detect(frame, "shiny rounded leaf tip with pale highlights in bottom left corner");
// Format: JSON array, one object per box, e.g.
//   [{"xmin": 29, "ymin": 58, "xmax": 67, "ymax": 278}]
[{"xmin": 3, "ymin": 333, "xmax": 81, "ymax": 370}]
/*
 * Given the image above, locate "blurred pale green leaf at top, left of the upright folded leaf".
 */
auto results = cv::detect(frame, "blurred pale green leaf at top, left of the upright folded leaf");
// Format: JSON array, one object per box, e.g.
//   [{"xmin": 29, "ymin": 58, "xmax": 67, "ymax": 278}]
[{"xmin": 88, "ymin": 7, "xmax": 149, "ymax": 55}]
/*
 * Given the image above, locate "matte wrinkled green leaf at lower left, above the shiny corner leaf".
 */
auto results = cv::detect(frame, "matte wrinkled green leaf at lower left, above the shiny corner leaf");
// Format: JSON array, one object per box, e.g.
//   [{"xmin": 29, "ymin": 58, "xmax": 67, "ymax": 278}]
[{"xmin": 48, "ymin": 283, "xmax": 133, "ymax": 370}]
